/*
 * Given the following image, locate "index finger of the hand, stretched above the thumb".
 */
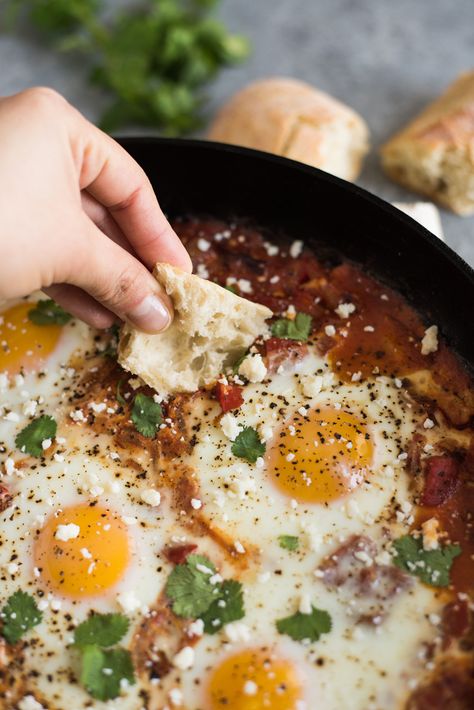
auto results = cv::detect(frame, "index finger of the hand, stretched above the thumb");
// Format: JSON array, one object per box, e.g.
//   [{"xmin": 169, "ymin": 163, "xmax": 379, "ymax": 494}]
[{"xmin": 67, "ymin": 112, "xmax": 192, "ymax": 271}]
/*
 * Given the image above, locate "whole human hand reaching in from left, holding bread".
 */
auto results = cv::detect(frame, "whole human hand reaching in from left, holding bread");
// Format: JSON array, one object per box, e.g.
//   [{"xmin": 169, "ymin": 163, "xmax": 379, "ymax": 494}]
[{"xmin": 0, "ymin": 88, "xmax": 191, "ymax": 332}]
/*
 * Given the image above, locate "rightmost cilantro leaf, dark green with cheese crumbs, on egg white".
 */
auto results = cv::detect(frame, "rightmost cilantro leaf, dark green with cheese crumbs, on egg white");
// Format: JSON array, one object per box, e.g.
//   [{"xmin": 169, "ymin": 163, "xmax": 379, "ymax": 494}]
[{"xmin": 393, "ymin": 535, "xmax": 461, "ymax": 587}]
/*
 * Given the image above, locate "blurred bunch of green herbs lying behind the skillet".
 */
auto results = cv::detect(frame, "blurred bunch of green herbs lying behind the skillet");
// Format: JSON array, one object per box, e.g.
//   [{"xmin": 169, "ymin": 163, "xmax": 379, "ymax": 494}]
[{"xmin": 3, "ymin": 0, "xmax": 249, "ymax": 135}]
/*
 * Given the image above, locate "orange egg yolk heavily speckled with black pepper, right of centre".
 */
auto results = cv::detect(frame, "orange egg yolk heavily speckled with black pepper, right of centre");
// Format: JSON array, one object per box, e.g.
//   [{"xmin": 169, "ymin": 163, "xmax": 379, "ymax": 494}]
[{"xmin": 267, "ymin": 408, "xmax": 373, "ymax": 503}]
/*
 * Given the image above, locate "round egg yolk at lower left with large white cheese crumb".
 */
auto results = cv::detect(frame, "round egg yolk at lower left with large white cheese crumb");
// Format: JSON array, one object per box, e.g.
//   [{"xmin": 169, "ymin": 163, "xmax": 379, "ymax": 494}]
[{"xmin": 35, "ymin": 505, "xmax": 130, "ymax": 598}]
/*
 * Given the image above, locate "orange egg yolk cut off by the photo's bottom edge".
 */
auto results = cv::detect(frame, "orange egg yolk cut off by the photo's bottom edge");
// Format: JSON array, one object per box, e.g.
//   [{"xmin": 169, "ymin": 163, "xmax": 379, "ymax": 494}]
[{"xmin": 208, "ymin": 649, "xmax": 303, "ymax": 710}]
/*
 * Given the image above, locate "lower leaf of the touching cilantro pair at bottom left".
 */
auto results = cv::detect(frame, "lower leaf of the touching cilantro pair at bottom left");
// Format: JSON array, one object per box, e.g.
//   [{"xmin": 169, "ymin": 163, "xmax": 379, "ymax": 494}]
[{"xmin": 81, "ymin": 646, "xmax": 135, "ymax": 700}]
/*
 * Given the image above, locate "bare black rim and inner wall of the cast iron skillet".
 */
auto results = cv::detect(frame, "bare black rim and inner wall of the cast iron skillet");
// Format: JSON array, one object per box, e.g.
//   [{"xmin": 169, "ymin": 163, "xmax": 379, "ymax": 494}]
[{"xmin": 120, "ymin": 138, "xmax": 474, "ymax": 370}]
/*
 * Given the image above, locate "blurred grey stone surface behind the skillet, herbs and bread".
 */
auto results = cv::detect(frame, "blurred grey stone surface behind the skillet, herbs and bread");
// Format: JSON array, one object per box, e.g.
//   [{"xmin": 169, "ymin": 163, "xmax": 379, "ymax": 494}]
[{"xmin": 0, "ymin": 0, "xmax": 474, "ymax": 264}]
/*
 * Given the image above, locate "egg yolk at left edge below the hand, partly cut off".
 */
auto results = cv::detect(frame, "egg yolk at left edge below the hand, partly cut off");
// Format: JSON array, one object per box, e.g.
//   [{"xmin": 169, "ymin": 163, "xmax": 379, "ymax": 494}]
[{"xmin": 0, "ymin": 301, "xmax": 62, "ymax": 375}]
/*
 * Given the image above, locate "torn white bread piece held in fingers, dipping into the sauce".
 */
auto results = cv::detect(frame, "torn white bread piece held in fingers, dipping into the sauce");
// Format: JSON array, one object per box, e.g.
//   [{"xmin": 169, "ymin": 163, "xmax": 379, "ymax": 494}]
[{"xmin": 118, "ymin": 264, "xmax": 272, "ymax": 395}]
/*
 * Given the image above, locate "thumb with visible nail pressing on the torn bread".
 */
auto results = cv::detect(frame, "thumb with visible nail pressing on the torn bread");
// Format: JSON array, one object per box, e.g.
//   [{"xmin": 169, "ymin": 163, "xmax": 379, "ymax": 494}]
[{"xmin": 66, "ymin": 215, "xmax": 173, "ymax": 333}]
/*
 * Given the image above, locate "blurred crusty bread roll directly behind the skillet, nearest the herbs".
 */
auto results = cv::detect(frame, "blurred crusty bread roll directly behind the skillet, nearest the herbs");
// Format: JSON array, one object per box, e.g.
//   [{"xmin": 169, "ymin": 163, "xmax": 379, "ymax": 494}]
[{"xmin": 208, "ymin": 78, "xmax": 369, "ymax": 180}]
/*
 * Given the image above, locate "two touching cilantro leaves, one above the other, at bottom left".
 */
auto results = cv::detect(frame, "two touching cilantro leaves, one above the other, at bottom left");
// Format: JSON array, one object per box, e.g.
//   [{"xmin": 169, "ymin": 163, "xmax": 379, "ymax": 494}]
[{"xmin": 74, "ymin": 614, "xmax": 135, "ymax": 701}]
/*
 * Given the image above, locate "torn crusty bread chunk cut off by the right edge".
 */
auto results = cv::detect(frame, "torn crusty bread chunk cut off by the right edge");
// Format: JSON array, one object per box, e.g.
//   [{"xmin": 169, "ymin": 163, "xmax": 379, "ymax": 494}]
[{"xmin": 381, "ymin": 71, "xmax": 474, "ymax": 215}]
